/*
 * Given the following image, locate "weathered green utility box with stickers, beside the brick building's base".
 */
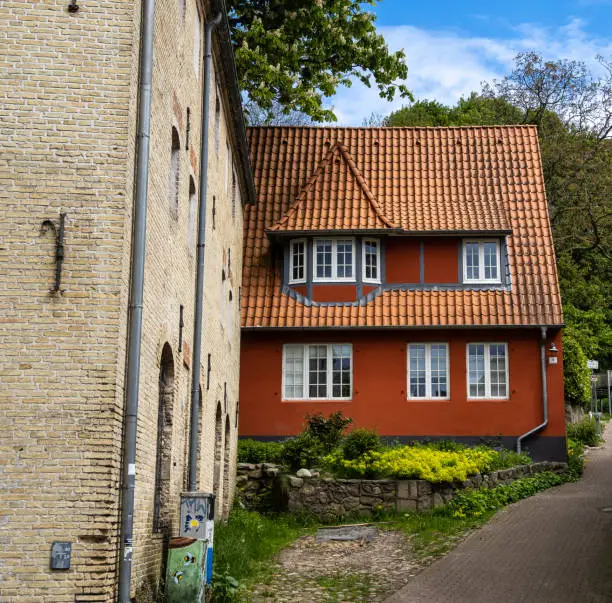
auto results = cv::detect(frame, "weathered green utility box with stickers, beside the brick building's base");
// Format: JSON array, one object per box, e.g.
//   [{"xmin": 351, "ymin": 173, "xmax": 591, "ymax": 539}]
[{"xmin": 166, "ymin": 537, "xmax": 207, "ymax": 603}]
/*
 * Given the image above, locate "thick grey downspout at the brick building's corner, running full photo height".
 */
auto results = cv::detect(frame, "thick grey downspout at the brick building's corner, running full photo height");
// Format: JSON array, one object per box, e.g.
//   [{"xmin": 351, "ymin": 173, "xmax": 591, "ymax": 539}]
[{"xmin": 118, "ymin": 0, "xmax": 155, "ymax": 603}]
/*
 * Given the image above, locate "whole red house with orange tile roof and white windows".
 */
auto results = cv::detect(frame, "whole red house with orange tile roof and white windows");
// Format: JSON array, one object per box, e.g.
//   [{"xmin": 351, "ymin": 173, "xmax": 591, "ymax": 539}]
[{"xmin": 239, "ymin": 126, "xmax": 566, "ymax": 460}]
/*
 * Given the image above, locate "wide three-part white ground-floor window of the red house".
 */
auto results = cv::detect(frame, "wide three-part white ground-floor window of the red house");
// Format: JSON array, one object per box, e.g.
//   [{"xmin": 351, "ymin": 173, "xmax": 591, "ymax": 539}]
[{"xmin": 283, "ymin": 343, "xmax": 353, "ymax": 400}]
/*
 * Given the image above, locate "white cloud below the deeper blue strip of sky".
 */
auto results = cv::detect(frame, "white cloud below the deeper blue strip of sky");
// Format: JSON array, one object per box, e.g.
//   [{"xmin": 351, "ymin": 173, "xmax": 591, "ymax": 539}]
[{"xmin": 333, "ymin": 18, "xmax": 612, "ymax": 125}]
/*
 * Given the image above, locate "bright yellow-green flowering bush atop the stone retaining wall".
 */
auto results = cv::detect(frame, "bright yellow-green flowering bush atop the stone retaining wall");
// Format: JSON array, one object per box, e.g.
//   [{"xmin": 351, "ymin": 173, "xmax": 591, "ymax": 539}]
[{"xmin": 326, "ymin": 446, "xmax": 499, "ymax": 483}]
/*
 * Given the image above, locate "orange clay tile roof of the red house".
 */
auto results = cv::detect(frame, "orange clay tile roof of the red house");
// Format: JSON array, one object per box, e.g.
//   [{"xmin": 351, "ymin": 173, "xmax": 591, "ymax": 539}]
[{"xmin": 242, "ymin": 126, "xmax": 563, "ymax": 328}]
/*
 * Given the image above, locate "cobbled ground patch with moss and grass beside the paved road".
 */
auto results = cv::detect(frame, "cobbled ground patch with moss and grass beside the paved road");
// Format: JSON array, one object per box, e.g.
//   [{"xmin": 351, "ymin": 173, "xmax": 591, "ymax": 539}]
[{"xmin": 246, "ymin": 529, "xmax": 421, "ymax": 603}]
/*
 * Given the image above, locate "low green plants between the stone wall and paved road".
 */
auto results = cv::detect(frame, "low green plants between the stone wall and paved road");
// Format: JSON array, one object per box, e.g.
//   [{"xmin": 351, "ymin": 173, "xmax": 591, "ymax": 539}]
[{"xmin": 440, "ymin": 471, "xmax": 565, "ymax": 518}]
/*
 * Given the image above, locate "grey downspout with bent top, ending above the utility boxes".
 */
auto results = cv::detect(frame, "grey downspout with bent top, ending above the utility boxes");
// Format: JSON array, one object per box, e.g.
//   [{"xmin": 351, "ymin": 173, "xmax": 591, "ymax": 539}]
[{"xmin": 188, "ymin": 13, "xmax": 223, "ymax": 492}]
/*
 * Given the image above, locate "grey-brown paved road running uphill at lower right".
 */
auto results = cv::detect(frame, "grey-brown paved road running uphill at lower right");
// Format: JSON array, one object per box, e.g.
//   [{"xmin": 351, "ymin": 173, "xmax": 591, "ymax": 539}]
[{"xmin": 386, "ymin": 425, "xmax": 612, "ymax": 603}]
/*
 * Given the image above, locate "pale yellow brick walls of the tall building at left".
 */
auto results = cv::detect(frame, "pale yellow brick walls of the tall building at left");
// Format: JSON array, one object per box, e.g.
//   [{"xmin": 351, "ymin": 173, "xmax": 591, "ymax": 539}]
[{"xmin": 0, "ymin": 0, "xmax": 254, "ymax": 602}]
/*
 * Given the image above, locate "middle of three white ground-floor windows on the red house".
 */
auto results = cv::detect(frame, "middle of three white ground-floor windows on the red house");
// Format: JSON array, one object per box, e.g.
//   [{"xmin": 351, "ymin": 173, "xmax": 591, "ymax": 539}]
[{"xmin": 408, "ymin": 343, "xmax": 450, "ymax": 400}]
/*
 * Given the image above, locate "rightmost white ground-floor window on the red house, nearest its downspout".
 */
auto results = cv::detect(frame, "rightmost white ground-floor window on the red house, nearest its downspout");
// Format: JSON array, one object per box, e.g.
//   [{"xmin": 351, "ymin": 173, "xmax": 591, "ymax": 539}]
[{"xmin": 467, "ymin": 343, "xmax": 508, "ymax": 400}]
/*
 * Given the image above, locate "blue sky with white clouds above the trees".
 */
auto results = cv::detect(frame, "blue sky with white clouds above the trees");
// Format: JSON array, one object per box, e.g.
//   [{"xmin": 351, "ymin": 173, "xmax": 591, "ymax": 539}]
[{"xmin": 331, "ymin": 0, "xmax": 612, "ymax": 125}]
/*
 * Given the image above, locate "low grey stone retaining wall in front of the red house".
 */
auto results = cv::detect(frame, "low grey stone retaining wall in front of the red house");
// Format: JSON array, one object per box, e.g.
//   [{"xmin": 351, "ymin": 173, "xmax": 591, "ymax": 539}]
[{"xmin": 237, "ymin": 461, "xmax": 567, "ymax": 520}]
